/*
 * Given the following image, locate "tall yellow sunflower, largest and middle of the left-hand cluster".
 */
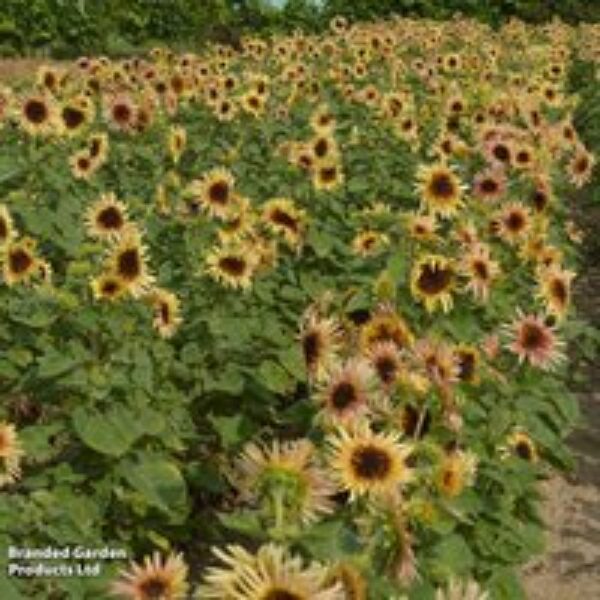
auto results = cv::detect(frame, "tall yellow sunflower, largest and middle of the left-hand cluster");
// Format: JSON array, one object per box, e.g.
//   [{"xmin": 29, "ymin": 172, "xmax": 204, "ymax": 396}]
[{"xmin": 107, "ymin": 226, "xmax": 154, "ymax": 298}]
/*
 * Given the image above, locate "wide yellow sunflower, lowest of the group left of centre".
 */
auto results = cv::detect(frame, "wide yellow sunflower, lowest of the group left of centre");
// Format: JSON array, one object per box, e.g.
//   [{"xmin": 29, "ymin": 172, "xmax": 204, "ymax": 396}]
[{"xmin": 206, "ymin": 244, "xmax": 258, "ymax": 289}]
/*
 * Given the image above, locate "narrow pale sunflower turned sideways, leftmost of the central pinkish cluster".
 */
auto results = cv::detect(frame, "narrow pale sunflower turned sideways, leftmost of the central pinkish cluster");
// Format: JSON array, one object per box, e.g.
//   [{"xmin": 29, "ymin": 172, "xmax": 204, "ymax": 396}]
[{"xmin": 299, "ymin": 309, "xmax": 343, "ymax": 381}]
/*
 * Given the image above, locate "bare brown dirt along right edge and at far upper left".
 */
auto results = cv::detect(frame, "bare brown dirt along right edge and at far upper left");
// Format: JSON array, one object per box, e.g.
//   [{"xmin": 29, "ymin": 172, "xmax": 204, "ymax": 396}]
[{"xmin": 0, "ymin": 59, "xmax": 600, "ymax": 600}]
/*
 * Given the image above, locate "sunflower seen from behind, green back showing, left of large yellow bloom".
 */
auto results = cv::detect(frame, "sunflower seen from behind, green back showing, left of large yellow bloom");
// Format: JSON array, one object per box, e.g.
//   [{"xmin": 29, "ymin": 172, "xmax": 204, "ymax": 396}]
[{"xmin": 230, "ymin": 439, "xmax": 336, "ymax": 525}]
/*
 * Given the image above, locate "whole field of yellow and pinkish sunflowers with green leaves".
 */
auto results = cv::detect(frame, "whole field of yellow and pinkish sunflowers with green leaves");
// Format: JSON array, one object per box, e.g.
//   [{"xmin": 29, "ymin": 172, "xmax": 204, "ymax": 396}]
[{"xmin": 0, "ymin": 12, "xmax": 600, "ymax": 600}]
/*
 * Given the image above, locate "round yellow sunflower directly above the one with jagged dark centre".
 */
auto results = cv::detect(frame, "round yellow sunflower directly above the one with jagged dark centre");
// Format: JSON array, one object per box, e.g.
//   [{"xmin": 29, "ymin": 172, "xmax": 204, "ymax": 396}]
[{"xmin": 417, "ymin": 163, "xmax": 462, "ymax": 217}]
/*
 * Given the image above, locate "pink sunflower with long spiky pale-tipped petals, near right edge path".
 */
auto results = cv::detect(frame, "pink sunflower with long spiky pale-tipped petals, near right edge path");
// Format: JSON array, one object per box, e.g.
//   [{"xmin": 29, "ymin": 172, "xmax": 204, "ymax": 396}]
[{"xmin": 503, "ymin": 312, "xmax": 565, "ymax": 370}]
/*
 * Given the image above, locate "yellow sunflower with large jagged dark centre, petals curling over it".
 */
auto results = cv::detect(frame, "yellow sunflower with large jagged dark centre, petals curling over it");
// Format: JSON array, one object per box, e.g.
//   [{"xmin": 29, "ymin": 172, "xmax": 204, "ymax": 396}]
[{"xmin": 410, "ymin": 254, "xmax": 457, "ymax": 312}]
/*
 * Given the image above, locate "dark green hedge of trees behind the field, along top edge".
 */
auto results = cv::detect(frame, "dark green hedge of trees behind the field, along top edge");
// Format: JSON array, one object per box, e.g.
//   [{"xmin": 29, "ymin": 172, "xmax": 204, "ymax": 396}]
[{"xmin": 0, "ymin": 0, "xmax": 600, "ymax": 58}]
